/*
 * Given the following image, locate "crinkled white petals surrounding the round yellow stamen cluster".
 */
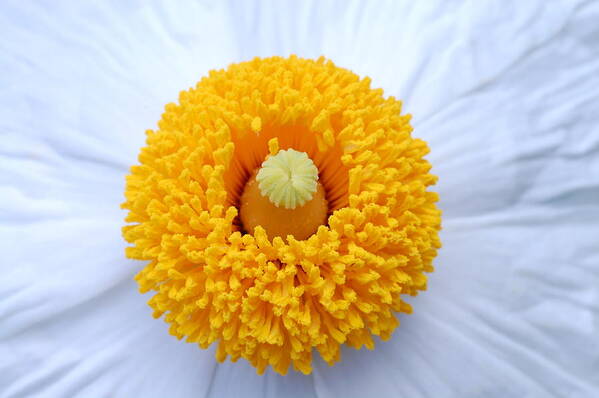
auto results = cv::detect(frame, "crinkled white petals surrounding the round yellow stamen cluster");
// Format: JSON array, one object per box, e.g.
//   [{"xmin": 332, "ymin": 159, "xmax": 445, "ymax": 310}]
[{"xmin": 0, "ymin": 0, "xmax": 599, "ymax": 398}]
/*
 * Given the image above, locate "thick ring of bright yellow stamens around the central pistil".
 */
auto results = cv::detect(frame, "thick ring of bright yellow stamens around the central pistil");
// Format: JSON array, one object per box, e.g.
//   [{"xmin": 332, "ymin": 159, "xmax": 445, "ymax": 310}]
[{"xmin": 123, "ymin": 56, "xmax": 440, "ymax": 374}]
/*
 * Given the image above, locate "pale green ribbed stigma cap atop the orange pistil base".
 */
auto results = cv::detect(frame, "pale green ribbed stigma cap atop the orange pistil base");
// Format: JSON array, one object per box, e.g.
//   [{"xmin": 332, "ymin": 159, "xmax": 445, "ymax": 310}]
[{"xmin": 256, "ymin": 149, "xmax": 318, "ymax": 209}]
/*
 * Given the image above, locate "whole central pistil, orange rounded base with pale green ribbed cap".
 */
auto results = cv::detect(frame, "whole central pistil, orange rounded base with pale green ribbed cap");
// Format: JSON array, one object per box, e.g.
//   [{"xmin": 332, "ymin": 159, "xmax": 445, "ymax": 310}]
[{"xmin": 239, "ymin": 149, "xmax": 328, "ymax": 240}]
